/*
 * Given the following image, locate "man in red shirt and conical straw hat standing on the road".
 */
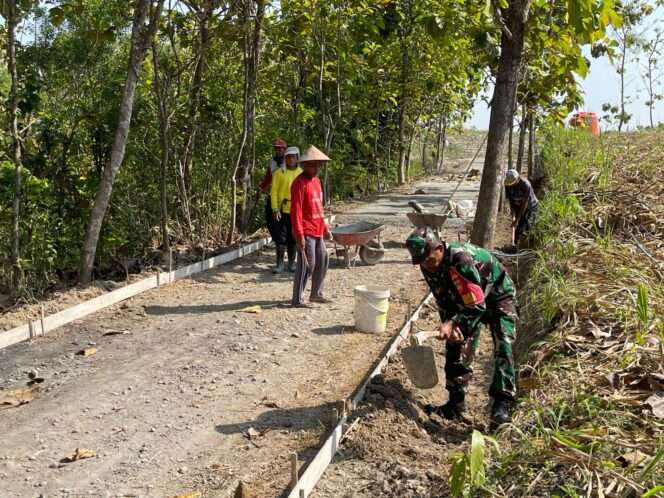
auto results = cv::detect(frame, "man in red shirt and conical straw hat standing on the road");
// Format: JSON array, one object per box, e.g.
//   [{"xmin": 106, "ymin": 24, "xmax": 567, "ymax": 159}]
[{"xmin": 290, "ymin": 145, "xmax": 330, "ymax": 307}]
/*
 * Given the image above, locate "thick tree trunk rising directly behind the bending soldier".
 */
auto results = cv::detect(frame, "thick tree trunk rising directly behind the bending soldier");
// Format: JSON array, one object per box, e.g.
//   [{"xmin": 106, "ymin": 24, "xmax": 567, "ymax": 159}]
[{"xmin": 471, "ymin": 0, "xmax": 530, "ymax": 248}]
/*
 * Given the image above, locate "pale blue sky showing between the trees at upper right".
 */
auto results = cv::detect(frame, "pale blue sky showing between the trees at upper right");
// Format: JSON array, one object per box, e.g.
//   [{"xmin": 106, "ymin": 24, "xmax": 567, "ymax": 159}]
[{"xmin": 466, "ymin": 10, "xmax": 664, "ymax": 130}]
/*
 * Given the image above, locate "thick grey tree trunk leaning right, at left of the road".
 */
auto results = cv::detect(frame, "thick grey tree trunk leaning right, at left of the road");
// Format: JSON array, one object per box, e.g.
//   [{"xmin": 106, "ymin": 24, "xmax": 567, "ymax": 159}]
[{"xmin": 79, "ymin": 0, "xmax": 164, "ymax": 284}]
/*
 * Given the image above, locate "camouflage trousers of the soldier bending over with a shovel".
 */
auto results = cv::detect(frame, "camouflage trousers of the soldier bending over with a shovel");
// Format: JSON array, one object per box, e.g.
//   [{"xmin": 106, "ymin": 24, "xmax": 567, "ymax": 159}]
[{"xmin": 445, "ymin": 297, "xmax": 517, "ymax": 399}]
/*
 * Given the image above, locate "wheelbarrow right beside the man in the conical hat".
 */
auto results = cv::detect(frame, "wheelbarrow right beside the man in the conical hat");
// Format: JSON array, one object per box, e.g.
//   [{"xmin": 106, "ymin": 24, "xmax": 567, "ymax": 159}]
[{"xmin": 330, "ymin": 221, "xmax": 385, "ymax": 268}]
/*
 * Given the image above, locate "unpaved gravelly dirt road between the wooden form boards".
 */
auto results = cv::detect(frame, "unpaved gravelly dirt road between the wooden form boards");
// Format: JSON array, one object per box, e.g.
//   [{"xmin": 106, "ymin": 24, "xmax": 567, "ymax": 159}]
[{"xmin": 0, "ymin": 176, "xmax": 477, "ymax": 498}]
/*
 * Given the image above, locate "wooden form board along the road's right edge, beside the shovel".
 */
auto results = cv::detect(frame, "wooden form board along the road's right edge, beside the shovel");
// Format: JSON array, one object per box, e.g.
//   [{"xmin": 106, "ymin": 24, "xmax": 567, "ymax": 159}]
[{"xmin": 288, "ymin": 294, "xmax": 433, "ymax": 498}]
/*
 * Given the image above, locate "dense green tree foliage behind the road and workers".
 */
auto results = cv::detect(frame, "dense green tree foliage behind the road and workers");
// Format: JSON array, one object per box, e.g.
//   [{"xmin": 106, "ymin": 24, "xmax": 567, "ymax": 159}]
[{"xmin": 0, "ymin": 0, "xmax": 616, "ymax": 296}]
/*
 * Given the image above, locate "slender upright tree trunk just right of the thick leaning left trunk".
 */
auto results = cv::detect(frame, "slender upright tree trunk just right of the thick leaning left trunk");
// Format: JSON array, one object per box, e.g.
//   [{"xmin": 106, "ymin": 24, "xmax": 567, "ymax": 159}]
[{"xmin": 152, "ymin": 42, "xmax": 171, "ymax": 251}]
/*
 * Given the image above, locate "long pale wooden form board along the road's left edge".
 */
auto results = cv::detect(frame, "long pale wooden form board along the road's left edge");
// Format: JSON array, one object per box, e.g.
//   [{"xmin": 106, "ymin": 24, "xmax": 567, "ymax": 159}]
[{"xmin": 0, "ymin": 216, "xmax": 334, "ymax": 349}]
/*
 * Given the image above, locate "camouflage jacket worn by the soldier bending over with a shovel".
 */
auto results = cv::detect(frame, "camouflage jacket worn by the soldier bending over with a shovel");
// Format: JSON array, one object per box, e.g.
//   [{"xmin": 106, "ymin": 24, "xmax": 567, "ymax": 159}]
[{"xmin": 422, "ymin": 242, "xmax": 515, "ymax": 334}]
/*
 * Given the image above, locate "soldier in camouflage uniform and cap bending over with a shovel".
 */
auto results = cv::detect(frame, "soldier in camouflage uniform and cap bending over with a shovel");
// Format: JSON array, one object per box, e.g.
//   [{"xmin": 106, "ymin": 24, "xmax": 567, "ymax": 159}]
[{"xmin": 406, "ymin": 228, "xmax": 517, "ymax": 425}]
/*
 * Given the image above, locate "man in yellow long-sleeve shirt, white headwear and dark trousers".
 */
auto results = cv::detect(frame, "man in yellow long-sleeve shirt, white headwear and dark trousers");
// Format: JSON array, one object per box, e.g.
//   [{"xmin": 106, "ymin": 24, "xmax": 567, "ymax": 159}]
[{"xmin": 271, "ymin": 147, "xmax": 302, "ymax": 274}]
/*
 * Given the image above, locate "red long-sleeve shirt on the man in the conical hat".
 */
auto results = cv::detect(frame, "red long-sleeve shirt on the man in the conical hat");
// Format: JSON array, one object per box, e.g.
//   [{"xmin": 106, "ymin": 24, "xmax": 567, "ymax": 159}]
[{"xmin": 290, "ymin": 175, "xmax": 327, "ymax": 240}]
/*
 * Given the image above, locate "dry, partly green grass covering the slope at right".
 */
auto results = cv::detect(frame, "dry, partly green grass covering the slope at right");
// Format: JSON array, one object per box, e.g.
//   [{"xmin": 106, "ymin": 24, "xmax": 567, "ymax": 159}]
[{"xmin": 485, "ymin": 132, "xmax": 664, "ymax": 498}]
